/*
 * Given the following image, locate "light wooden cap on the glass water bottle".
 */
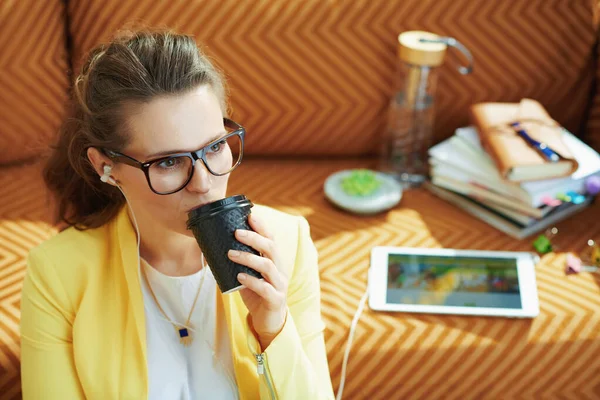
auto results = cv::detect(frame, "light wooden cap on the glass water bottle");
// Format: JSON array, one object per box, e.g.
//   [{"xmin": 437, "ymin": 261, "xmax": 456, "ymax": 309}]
[{"xmin": 398, "ymin": 31, "xmax": 447, "ymax": 67}]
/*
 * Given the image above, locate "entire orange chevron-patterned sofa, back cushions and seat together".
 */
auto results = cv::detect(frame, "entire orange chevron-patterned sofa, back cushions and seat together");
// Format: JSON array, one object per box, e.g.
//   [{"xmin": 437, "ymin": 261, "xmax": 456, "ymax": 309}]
[{"xmin": 0, "ymin": 0, "xmax": 600, "ymax": 399}]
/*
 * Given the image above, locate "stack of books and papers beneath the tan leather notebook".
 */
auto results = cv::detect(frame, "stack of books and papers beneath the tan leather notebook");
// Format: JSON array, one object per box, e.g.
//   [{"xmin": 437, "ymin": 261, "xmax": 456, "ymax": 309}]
[{"xmin": 425, "ymin": 99, "xmax": 600, "ymax": 239}]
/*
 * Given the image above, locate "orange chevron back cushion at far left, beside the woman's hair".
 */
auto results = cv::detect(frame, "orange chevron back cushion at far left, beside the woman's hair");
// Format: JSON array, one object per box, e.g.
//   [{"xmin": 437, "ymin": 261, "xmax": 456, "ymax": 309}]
[{"xmin": 0, "ymin": 0, "xmax": 69, "ymax": 165}]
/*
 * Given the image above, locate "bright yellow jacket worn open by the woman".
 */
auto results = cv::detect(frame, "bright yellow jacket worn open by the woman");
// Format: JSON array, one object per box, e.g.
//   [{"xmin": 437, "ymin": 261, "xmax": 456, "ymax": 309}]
[{"xmin": 21, "ymin": 205, "xmax": 333, "ymax": 400}]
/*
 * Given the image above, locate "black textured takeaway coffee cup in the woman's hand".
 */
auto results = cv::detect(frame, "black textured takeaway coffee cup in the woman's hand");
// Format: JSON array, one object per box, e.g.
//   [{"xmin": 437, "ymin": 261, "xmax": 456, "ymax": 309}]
[{"xmin": 187, "ymin": 195, "xmax": 262, "ymax": 294}]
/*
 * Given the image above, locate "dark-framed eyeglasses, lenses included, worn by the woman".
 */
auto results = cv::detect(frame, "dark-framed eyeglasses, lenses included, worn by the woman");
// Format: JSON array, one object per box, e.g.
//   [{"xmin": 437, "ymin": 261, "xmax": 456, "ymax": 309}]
[{"xmin": 103, "ymin": 118, "xmax": 246, "ymax": 195}]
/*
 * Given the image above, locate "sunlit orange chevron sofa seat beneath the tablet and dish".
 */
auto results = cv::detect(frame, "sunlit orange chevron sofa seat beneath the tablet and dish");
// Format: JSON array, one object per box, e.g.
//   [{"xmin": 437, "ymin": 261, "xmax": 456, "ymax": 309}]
[{"xmin": 0, "ymin": 159, "xmax": 600, "ymax": 400}]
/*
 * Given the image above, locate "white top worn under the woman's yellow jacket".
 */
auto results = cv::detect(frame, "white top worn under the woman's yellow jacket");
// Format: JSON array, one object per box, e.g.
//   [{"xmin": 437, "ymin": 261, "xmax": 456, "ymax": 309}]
[{"xmin": 140, "ymin": 259, "xmax": 238, "ymax": 400}]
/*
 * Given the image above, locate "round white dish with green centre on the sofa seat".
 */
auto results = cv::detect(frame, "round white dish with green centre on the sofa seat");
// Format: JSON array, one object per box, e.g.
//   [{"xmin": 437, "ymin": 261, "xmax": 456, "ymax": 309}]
[{"xmin": 323, "ymin": 169, "xmax": 402, "ymax": 215}]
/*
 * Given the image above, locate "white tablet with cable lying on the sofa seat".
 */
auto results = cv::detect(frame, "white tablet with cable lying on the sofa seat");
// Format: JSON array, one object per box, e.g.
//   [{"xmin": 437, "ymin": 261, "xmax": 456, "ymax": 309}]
[{"xmin": 368, "ymin": 247, "xmax": 539, "ymax": 318}]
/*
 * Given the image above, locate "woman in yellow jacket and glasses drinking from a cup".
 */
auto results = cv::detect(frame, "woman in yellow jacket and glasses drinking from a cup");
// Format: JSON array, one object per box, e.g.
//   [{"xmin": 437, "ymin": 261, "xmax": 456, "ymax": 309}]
[{"xmin": 21, "ymin": 28, "xmax": 333, "ymax": 400}]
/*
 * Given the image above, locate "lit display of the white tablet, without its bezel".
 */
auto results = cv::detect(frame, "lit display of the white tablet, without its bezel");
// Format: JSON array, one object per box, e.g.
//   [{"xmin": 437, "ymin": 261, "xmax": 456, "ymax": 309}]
[{"xmin": 387, "ymin": 254, "xmax": 522, "ymax": 308}]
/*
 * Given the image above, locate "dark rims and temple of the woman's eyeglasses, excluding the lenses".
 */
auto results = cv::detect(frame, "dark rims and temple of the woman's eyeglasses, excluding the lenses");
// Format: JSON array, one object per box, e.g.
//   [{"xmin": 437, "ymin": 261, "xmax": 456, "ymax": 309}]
[{"xmin": 101, "ymin": 118, "xmax": 246, "ymax": 196}]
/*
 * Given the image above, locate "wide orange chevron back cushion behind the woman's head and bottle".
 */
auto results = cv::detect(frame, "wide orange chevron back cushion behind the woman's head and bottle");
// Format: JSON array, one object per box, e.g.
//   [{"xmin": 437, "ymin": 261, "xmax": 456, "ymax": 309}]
[{"xmin": 68, "ymin": 0, "xmax": 596, "ymax": 155}]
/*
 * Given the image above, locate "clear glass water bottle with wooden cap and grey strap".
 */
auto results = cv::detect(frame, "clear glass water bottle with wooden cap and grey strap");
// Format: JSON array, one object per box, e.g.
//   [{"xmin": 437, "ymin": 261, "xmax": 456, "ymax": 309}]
[{"xmin": 380, "ymin": 31, "xmax": 472, "ymax": 187}]
